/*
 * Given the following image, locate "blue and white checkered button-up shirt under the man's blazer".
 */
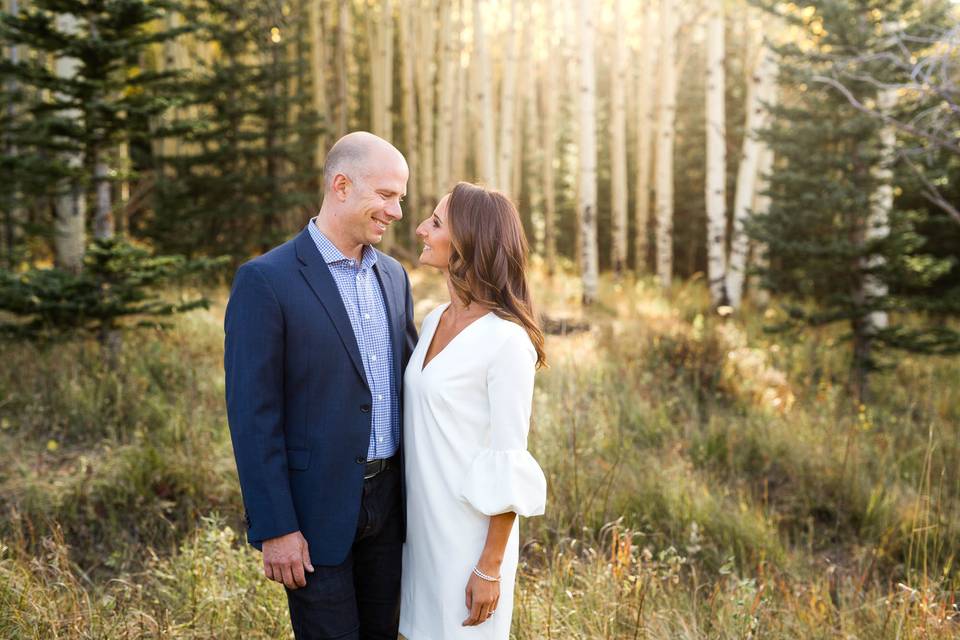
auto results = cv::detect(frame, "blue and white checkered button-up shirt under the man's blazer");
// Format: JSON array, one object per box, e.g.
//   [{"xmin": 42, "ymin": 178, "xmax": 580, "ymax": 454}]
[{"xmin": 309, "ymin": 218, "xmax": 400, "ymax": 460}]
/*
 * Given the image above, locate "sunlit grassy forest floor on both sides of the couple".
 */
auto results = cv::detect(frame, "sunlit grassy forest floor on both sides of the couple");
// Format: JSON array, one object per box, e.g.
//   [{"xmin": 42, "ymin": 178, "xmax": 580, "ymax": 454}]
[{"xmin": 0, "ymin": 262, "xmax": 960, "ymax": 640}]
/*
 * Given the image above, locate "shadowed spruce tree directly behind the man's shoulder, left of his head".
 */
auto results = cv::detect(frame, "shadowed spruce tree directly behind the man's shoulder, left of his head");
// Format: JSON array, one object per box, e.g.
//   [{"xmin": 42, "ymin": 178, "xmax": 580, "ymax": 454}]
[{"xmin": 147, "ymin": 0, "xmax": 321, "ymax": 261}]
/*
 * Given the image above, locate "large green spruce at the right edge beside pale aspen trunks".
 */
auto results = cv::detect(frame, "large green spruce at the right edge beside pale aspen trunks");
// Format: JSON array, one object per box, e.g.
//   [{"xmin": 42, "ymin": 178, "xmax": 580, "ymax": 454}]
[{"xmin": 749, "ymin": 0, "xmax": 960, "ymax": 402}]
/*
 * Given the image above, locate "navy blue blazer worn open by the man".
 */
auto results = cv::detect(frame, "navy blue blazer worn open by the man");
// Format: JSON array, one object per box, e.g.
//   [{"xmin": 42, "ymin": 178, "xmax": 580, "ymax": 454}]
[{"xmin": 224, "ymin": 228, "xmax": 417, "ymax": 565}]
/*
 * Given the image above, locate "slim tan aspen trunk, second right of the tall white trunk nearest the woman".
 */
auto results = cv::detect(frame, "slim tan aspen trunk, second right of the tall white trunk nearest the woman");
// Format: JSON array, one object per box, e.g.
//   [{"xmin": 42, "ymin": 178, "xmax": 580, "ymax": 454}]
[{"xmin": 634, "ymin": 2, "xmax": 657, "ymax": 273}]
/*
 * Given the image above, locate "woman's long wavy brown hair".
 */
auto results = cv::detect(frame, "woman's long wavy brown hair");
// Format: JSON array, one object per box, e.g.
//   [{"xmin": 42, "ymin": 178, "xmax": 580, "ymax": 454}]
[{"xmin": 447, "ymin": 182, "xmax": 547, "ymax": 367}]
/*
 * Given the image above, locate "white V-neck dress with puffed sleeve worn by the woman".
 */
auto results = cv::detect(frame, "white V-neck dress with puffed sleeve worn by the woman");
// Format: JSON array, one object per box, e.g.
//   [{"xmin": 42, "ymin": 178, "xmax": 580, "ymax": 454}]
[{"xmin": 400, "ymin": 303, "xmax": 547, "ymax": 640}]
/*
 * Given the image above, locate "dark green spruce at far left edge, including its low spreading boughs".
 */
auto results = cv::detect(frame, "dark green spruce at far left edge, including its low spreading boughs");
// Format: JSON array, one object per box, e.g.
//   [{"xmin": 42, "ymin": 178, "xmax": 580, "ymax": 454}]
[{"xmin": 0, "ymin": 0, "xmax": 218, "ymax": 350}]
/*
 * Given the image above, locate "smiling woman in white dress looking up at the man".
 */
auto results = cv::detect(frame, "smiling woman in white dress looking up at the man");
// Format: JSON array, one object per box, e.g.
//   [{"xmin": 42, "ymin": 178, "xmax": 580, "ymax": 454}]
[{"xmin": 400, "ymin": 182, "xmax": 546, "ymax": 640}]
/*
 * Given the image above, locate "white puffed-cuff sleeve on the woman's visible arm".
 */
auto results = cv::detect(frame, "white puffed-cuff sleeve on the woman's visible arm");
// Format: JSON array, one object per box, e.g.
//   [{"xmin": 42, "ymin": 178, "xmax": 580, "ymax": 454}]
[{"xmin": 461, "ymin": 329, "xmax": 547, "ymax": 516}]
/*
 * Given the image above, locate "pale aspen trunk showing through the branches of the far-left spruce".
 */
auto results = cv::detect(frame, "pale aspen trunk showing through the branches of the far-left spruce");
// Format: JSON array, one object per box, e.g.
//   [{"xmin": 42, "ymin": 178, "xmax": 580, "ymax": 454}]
[{"xmin": 54, "ymin": 13, "xmax": 87, "ymax": 273}]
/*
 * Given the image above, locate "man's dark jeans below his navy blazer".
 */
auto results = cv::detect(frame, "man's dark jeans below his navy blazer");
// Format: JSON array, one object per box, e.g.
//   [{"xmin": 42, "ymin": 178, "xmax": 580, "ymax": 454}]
[{"xmin": 287, "ymin": 466, "xmax": 403, "ymax": 640}]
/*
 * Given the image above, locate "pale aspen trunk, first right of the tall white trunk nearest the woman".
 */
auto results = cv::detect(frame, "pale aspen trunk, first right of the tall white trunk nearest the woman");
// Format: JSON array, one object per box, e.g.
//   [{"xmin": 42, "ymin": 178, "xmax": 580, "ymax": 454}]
[{"xmin": 610, "ymin": 0, "xmax": 629, "ymax": 276}]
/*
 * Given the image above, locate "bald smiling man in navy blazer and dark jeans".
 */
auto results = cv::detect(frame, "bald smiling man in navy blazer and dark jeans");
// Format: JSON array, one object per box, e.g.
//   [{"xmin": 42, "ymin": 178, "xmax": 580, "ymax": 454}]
[{"xmin": 224, "ymin": 132, "xmax": 416, "ymax": 640}]
